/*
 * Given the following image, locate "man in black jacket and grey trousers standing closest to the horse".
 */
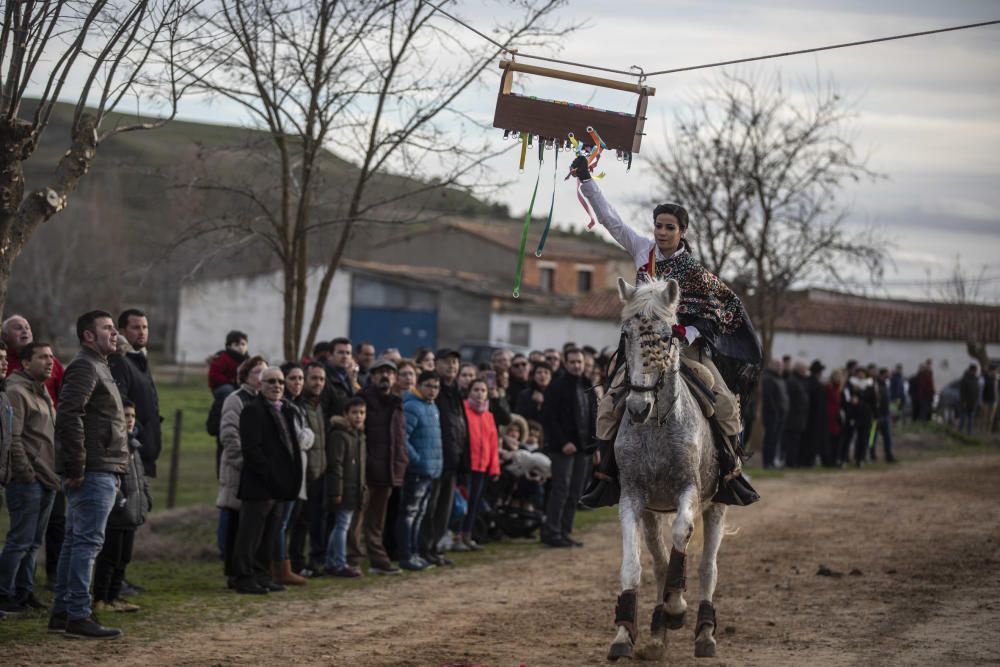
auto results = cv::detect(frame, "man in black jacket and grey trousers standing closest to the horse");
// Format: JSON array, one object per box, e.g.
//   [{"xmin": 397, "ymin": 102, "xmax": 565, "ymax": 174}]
[{"xmin": 542, "ymin": 348, "xmax": 597, "ymax": 547}]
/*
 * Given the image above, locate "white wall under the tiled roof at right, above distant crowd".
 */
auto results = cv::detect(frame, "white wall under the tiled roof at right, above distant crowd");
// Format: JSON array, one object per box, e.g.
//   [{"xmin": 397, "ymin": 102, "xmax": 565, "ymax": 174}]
[{"xmin": 774, "ymin": 331, "xmax": 1000, "ymax": 387}]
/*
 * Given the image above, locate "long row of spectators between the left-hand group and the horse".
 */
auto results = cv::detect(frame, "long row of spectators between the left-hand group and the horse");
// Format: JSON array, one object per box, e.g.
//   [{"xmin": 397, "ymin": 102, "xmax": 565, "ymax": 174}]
[{"xmin": 207, "ymin": 331, "xmax": 603, "ymax": 595}]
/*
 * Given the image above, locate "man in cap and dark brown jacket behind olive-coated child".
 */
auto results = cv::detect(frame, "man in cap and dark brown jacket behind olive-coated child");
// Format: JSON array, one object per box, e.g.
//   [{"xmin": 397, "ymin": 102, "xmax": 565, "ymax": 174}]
[{"xmin": 347, "ymin": 359, "xmax": 409, "ymax": 574}]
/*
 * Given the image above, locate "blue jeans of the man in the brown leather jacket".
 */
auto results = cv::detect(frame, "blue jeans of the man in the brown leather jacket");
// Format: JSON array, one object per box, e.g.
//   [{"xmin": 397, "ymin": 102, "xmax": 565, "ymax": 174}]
[{"xmin": 52, "ymin": 472, "xmax": 118, "ymax": 621}]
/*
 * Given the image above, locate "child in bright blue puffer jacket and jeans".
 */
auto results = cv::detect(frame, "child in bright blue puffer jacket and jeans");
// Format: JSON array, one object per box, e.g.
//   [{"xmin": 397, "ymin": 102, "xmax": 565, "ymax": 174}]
[{"xmin": 396, "ymin": 371, "xmax": 443, "ymax": 570}]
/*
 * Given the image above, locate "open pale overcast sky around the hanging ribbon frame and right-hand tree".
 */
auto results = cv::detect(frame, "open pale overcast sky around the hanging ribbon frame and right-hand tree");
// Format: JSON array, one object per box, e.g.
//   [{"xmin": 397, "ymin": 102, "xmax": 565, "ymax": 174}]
[{"xmin": 105, "ymin": 0, "xmax": 1000, "ymax": 302}]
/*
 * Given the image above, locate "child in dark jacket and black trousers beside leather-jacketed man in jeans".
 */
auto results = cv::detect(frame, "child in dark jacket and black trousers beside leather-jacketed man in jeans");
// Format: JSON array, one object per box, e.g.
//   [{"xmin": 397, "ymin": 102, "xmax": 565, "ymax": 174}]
[{"xmin": 94, "ymin": 399, "xmax": 153, "ymax": 612}]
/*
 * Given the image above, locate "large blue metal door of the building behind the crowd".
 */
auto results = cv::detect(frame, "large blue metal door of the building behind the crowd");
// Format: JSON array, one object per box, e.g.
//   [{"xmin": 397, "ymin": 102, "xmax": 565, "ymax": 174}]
[{"xmin": 351, "ymin": 306, "xmax": 437, "ymax": 357}]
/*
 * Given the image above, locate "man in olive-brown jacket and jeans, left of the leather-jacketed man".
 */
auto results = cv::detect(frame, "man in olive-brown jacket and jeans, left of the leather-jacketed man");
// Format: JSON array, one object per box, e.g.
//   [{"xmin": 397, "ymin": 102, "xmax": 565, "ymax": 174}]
[{"xmin": 0, "ymin": 343, "xmax": 59, "ymax": 615}]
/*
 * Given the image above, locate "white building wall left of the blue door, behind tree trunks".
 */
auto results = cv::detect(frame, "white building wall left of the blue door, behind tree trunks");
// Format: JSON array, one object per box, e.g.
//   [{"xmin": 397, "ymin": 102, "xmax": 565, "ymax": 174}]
[{"xmin": 175, "ymin": 270, "xmax": 351, "ymax": 363}]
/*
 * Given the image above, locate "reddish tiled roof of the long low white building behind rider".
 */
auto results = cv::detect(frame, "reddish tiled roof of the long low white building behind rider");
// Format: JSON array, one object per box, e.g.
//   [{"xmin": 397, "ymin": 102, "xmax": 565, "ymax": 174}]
[{"xmin": 572, "ymin": 290, "xmax": 1000, "ymax": 343}]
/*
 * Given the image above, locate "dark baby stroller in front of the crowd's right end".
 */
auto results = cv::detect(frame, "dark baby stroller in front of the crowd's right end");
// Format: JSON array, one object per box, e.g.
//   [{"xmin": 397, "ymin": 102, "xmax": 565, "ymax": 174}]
[{"xmin": 473, "ymin": 449, "xmax": 552, "ymax": 542}]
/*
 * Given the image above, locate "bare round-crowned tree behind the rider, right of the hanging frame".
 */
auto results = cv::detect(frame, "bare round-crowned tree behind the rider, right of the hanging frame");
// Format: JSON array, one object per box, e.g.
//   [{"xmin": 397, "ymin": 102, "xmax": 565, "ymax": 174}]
[{"xmin": 652, "ymin": 74, "xmax": 884, "ymax": 366}]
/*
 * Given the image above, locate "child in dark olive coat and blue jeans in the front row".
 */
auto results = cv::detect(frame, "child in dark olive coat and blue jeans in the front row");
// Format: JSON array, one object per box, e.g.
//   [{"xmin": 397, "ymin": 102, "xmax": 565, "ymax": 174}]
[{"xmin": 326, "ymin": 396, "xmax": 367, "ymax": 578}]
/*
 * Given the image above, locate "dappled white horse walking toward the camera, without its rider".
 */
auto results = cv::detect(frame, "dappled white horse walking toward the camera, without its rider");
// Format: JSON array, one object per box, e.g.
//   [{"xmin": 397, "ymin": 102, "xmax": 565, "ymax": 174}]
[{"xmin": 608, "ymin": 279, "xmax": 726, "ymax": 660}]
